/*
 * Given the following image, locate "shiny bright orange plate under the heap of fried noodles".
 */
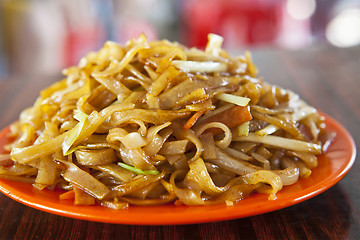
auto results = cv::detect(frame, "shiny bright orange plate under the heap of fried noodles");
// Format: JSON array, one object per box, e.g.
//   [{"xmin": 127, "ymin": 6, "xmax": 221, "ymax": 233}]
[{"xmin": 0, "ymin": 115, "xmax": 356, "ymax": 225}]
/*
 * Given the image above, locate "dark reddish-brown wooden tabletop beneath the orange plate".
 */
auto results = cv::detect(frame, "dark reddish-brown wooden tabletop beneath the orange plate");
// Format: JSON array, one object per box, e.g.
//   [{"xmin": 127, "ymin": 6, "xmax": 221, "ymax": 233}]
[{"xmin": 0, "ymin": 46, "xmax": 360, "ymax": 240}]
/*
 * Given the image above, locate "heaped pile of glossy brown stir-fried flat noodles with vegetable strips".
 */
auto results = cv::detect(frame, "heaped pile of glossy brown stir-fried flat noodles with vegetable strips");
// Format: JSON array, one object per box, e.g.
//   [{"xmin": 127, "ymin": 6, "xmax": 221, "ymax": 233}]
[{"xmin": 0, "ymin": 34, "xmax": 332, "ymax": 209}]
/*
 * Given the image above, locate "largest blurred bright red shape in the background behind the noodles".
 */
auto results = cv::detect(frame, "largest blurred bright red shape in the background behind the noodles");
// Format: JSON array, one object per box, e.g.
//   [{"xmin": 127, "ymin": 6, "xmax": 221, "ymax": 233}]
[{"xmin": 181, "ymin": 0, "xmax": 284, "ymax": 47}]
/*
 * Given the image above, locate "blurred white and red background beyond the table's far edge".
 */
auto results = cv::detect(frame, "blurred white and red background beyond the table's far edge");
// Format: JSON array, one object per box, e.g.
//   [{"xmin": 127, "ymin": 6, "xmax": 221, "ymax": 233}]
[{"xmin": 0, "ymin": 0, "xmax": 360, "ymax": 79}]
